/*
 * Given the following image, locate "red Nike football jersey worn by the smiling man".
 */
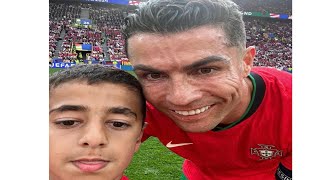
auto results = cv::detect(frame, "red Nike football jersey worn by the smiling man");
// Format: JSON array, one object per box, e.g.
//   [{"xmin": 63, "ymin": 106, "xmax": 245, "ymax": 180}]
[{"xmin": 143, "ymin": 68, "xmax": 292, "ymax": 180}]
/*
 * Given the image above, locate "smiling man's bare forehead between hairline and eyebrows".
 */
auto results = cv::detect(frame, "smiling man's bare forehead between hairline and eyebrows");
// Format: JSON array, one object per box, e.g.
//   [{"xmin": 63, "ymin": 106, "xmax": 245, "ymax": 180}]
[{"xmin": 127, "ymin": 26, "xmax": 228, "ymax": 61}]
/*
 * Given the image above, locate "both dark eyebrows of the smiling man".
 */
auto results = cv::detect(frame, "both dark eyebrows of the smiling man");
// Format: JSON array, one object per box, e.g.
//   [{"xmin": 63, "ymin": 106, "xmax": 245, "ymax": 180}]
[{"xmin": 133, "ymin": 55, "xmax": 230, "ymax": 73}]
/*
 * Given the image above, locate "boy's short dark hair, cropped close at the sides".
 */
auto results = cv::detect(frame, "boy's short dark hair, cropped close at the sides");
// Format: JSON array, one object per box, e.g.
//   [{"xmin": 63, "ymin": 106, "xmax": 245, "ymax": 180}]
[{"xmin": 49, "ymin": 64, "xmax": 146, "ymax": 125}]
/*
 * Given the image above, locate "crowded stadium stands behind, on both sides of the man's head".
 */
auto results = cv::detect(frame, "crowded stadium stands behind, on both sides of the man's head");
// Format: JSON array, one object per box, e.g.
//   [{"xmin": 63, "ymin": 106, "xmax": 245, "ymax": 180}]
[{"xmin": 49, "ymin": 0, "xmax": 292, "ymax": 70}]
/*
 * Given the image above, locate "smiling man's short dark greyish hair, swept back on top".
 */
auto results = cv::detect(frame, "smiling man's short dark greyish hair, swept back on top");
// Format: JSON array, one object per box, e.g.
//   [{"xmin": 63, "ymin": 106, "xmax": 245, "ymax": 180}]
[{"xmin": 122, "ymin": 0, "xmax": 246, "ymax": 50}]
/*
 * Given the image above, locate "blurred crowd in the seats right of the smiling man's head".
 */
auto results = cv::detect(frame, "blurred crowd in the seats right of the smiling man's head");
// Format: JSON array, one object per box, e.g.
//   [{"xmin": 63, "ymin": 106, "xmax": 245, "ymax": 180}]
[{"xmin": 245, "ymin": 18, "xmax": 292, "ymax": 69}]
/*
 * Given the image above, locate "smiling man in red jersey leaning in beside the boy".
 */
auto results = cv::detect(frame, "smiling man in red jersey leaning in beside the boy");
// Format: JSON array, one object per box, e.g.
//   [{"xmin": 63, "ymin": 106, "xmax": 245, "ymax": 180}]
[{"xmin": 123, "ymin": 0, "xmax": 292, "ymax": 180}]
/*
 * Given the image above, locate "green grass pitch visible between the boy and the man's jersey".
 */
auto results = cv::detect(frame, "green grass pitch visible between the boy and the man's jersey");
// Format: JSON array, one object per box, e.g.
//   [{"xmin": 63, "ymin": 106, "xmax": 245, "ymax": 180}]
[{"xmin": 49, "ymin": 68, "xmax": 183, "ymax": 180}]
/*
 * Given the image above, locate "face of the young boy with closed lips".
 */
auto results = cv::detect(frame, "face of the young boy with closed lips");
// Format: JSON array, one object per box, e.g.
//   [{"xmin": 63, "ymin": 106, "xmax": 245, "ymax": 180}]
[{"xmin": 49, "ymin": 82, "xmax": 142, "ymax": 180}]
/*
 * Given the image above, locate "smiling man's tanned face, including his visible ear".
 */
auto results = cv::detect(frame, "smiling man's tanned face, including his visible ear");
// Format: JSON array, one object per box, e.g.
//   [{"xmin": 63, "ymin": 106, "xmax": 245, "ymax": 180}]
[{"xmin": 128, "ymin": 26, "xmax": 255, "ymax": 132}]
